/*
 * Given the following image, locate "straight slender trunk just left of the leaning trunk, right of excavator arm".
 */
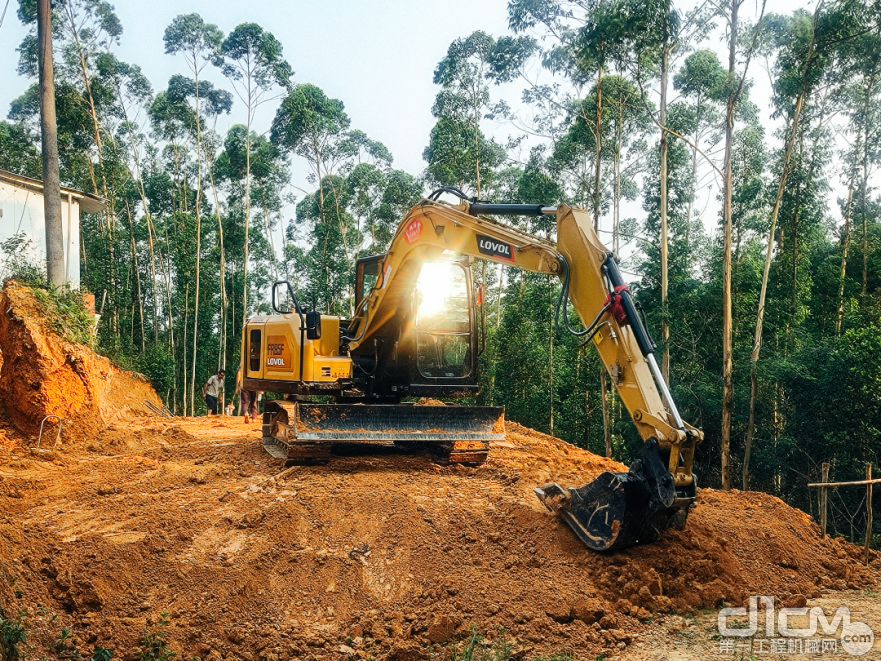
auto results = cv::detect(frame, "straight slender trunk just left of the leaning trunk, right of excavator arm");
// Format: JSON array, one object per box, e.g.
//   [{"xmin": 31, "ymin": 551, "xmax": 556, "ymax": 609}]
[{"xmin": 720, "ymin": 0, "xmax": 742, "ymax": 490}]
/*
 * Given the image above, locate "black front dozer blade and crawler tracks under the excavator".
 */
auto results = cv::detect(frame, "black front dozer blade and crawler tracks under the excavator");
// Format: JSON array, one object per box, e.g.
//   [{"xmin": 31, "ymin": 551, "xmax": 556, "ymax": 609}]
[{"xmin": 263, "ymin": 401, "xmax": 505, "ymax": 466}]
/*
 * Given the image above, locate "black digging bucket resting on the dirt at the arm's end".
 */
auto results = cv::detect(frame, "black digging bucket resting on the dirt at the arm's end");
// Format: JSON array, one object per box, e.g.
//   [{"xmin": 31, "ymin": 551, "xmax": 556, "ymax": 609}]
[{"xmin": 535, "ymin": 438, "xmax": 697, "ymax": 551}]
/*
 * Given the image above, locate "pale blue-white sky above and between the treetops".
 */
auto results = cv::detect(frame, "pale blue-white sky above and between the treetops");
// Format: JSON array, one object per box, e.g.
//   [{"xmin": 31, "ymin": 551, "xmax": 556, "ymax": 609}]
[{"xmin": 0, "ymin": 0, "xmax": 834, "ymax": 260}]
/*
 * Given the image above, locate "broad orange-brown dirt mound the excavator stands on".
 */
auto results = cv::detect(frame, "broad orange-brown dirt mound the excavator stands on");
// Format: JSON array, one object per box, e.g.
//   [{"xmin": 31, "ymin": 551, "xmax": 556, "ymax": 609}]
[{"xmin": 0, "ymin": 417, "xmax": 879, "ymax": 661}]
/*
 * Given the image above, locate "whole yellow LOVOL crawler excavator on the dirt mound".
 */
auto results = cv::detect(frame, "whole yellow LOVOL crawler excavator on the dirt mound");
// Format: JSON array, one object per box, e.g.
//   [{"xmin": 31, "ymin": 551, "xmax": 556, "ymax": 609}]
[{"xmin": 241, "ymin": 188, "xmax": 703, "ymax": 551}]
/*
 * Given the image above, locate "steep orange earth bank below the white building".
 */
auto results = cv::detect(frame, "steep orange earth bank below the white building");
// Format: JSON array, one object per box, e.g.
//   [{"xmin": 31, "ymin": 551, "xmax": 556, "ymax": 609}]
[{"xmin": 0, "ymin": 282, "xmax": 162, "ymax": 440}]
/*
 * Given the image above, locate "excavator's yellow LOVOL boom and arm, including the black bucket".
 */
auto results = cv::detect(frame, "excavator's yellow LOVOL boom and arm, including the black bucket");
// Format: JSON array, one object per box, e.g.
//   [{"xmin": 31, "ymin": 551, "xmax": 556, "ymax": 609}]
[{"xmin": 342, "ymin": 199, "xmax": 702, "ymax": 550}]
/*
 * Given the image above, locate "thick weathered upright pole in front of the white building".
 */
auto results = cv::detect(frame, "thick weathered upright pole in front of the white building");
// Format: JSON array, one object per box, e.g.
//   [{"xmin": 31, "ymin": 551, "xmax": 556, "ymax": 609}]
[{"xmin": 37, "ymin": 0, "xmax": 67, "ymax": 289}]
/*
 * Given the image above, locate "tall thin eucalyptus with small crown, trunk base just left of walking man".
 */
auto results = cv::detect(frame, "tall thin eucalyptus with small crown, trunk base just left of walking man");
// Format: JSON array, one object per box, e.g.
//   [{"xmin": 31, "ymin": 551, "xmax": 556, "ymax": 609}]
[{"xmin": 163, "ymin": 14, "xmax": 223, "ymax": 414}]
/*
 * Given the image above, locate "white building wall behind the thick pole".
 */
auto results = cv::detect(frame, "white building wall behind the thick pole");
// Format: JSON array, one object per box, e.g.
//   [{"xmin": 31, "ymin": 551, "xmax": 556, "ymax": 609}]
[{"xmin": 0, "ymin": 180, "xmax": 80, "ymax": 289}]
